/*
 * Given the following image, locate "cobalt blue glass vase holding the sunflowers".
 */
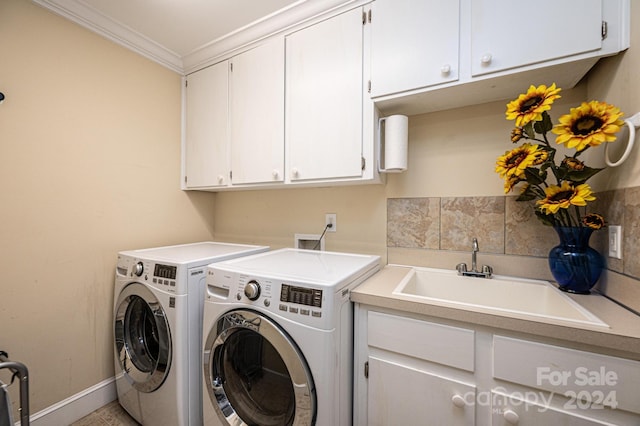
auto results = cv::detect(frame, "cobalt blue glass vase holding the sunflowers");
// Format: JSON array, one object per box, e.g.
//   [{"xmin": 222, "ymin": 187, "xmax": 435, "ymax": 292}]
[{"xmin": 549, "ymin": 226, "xmax": 604, "ymax": 294}]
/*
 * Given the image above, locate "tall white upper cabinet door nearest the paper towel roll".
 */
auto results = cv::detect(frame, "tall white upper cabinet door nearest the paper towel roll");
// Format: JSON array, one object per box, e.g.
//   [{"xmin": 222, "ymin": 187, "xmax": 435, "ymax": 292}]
[{"xmin": 286, "ymin": 9, "xmax": 363, "ymax": 181}]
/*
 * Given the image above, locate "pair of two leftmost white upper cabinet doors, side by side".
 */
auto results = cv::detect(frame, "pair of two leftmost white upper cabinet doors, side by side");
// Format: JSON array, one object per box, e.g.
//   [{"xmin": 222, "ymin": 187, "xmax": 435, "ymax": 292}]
[{"xmin": 184, "ymin": 37, "xmax": 284, "ymax": 189}]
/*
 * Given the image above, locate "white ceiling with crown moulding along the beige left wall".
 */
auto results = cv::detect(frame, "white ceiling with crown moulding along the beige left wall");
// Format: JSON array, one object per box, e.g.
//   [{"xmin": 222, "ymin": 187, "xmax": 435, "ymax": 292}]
[{"xmin": 33, "ymin": 0, "xmax": 306, "ymax": 72}]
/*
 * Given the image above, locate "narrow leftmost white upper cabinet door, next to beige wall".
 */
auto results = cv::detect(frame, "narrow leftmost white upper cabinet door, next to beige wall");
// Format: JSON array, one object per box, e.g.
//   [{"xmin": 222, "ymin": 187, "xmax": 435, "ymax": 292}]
[{"xmin": 184, "ymin": 61, "xmax": 229, "ymax": 188}]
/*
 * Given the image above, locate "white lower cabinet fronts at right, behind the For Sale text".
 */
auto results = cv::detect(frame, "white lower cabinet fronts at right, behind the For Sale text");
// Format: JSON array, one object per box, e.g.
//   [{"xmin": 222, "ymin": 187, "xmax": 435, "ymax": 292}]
[{"xmin": 491, "ymin": 335, "xmax": 640, "ymax": 426}]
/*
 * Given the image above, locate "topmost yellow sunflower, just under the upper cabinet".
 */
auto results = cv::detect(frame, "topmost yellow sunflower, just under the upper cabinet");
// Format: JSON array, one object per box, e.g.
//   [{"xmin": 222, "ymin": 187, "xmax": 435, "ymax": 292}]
[{"xmin": 506, "ymin": 83, "xmax": 561, "ymax": 127}]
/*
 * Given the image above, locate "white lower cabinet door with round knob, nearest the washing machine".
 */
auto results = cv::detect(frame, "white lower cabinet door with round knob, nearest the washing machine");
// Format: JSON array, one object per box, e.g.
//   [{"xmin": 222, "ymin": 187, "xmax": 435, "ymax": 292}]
[{"xmin": 367, "ymin": 357, "xmax": 476, "ymax": 426}]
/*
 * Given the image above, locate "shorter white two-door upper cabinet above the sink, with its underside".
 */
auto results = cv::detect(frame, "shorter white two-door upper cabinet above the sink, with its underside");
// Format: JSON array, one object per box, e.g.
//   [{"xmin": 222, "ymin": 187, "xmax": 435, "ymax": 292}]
[{"xmin": 372, "ymin": 0, "xmax": 630, "ymax": 115}]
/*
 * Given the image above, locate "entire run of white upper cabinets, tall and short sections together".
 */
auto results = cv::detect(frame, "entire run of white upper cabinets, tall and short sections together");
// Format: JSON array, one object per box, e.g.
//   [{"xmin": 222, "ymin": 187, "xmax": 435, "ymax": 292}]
[{"xmin": 182, "ymin": 0, "xmax": 630, "ymax": 190}]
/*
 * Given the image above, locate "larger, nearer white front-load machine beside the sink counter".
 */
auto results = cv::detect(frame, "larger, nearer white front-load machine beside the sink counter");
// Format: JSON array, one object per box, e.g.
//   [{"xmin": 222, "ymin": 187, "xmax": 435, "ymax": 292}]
[{"xmin": 202, "ymin": 249, "xmax": 380, "ymax": 426}]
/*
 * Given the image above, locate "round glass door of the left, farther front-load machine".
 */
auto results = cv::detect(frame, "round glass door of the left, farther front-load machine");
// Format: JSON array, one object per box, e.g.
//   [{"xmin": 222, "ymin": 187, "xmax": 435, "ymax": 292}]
[{"xmin": 114, "ymin": 283, "xmax": 172, "ymax": 392}]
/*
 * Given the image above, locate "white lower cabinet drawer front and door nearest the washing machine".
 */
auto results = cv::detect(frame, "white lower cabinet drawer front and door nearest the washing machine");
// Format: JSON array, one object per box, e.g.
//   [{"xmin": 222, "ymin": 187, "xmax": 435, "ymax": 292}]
[{"xmin": 354, "ymin": 311, "xmax": 476, "ymax": 426}]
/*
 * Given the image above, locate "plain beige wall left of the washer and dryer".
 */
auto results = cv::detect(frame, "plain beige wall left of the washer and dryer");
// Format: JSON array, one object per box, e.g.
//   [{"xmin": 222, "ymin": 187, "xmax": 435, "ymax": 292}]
[{"xmin": 0, "ymin": 0, "xmax": 214, "ymax": 413}]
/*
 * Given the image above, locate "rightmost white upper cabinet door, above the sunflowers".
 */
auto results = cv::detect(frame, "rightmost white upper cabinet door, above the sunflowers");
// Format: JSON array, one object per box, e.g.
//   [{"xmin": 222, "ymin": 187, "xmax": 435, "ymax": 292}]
[{"xmin": 471, "ymin": 0, "xmax": 602, "ymax": 76}]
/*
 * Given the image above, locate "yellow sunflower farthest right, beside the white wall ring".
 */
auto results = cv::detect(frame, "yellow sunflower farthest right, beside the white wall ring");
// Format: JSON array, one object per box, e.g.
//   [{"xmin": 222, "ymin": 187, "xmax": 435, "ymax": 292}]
[{"xmin": 552, "ymin": 101, "xmax": 624, "ymax": 151}]
